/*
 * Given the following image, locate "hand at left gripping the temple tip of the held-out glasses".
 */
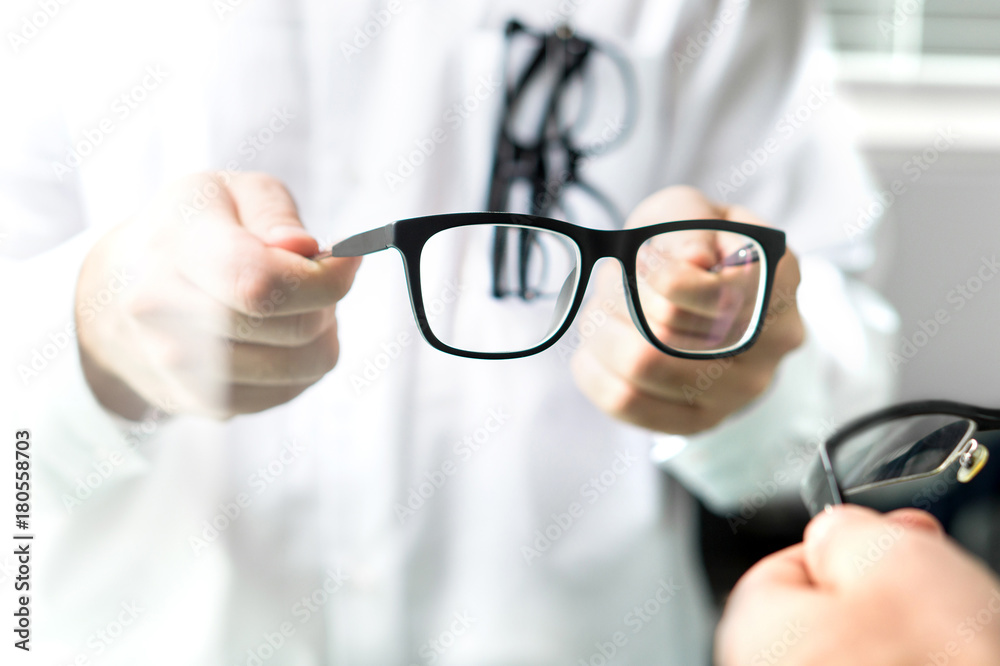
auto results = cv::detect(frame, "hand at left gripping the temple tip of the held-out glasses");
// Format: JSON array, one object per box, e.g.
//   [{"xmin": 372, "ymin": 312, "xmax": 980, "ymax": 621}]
[{"xmin": 76, "ymin": 174, "xmax": 360, "ymax": 418}]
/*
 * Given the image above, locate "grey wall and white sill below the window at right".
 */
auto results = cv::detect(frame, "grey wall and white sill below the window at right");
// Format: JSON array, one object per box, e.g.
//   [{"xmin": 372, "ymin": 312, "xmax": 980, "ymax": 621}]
[{"xmin": 844, "ymin": 78, "xmax": 1000, "ymax": 407}]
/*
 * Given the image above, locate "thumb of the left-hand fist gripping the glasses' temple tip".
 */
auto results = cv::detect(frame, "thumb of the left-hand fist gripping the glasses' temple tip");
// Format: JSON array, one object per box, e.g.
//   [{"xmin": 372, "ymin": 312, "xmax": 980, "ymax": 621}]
[{"xmin": 229, "ymin": 173, "xmax": 319, "ymax": 257}]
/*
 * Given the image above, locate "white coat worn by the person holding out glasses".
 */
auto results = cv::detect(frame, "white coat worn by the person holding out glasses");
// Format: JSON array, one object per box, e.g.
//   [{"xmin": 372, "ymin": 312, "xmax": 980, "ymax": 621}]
[{"xmin": 0, "ymin": 0, "xmax": 894, "ymax": 666}]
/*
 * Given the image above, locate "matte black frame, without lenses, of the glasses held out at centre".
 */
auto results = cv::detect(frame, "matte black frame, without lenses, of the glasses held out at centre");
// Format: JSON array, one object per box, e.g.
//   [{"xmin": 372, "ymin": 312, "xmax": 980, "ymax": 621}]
[{"xmin": 318, "ymin": 212, "xmax": 786, "ymax": 360}]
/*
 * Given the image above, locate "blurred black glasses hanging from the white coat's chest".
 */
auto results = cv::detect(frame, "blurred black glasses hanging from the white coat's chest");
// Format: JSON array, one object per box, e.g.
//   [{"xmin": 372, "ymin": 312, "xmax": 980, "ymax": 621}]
[{"xmin": 486, "ymin": 20, "xmax": 638, "ymax": 299}]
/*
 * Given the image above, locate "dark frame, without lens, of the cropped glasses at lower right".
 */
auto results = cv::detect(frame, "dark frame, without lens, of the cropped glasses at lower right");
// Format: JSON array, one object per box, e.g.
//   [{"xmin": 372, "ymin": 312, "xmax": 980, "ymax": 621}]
[{"xmin": 801, "ymin": 400, "xmax": 1000, "ymax": 515}]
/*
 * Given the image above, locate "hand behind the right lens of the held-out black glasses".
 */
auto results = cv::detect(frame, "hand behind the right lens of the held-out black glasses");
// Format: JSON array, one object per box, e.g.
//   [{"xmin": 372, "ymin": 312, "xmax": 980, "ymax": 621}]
[{"xmin": 572, "ymin": 187, "xmax": 805, "ymax": 434}]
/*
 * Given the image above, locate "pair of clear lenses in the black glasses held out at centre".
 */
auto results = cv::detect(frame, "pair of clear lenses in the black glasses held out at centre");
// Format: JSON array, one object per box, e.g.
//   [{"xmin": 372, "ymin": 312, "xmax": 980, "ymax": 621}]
[{"xmin": 419, "ymin": 224, "xmax": 766, "ymax": 353}]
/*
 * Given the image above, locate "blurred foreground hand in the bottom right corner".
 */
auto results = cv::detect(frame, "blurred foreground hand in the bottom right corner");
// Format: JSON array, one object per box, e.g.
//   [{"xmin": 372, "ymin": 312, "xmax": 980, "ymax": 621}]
[{"xmin": 716, "ymin": 505, "xmax": 1000, "ymax": 666}]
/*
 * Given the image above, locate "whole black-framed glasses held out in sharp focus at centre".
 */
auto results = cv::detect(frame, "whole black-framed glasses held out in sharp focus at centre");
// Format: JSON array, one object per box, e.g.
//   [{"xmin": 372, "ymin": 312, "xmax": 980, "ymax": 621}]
[{"xmin": 314, "ymin": 213, "xmax": 785, "ymax": 359}]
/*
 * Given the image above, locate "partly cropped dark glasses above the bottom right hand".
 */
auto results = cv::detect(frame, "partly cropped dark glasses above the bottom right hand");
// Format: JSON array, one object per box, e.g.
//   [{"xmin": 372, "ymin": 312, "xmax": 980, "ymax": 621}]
[{"xmin": 802, "ymin": 400, "xmax": 1000, "ymax": 516}]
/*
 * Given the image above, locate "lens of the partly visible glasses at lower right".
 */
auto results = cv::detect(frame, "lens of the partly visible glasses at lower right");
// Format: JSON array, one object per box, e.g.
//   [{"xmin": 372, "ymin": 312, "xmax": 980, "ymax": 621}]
[{"xmin": 832, "ymin": 414, "xmax": 975, "ymax": 492}]
